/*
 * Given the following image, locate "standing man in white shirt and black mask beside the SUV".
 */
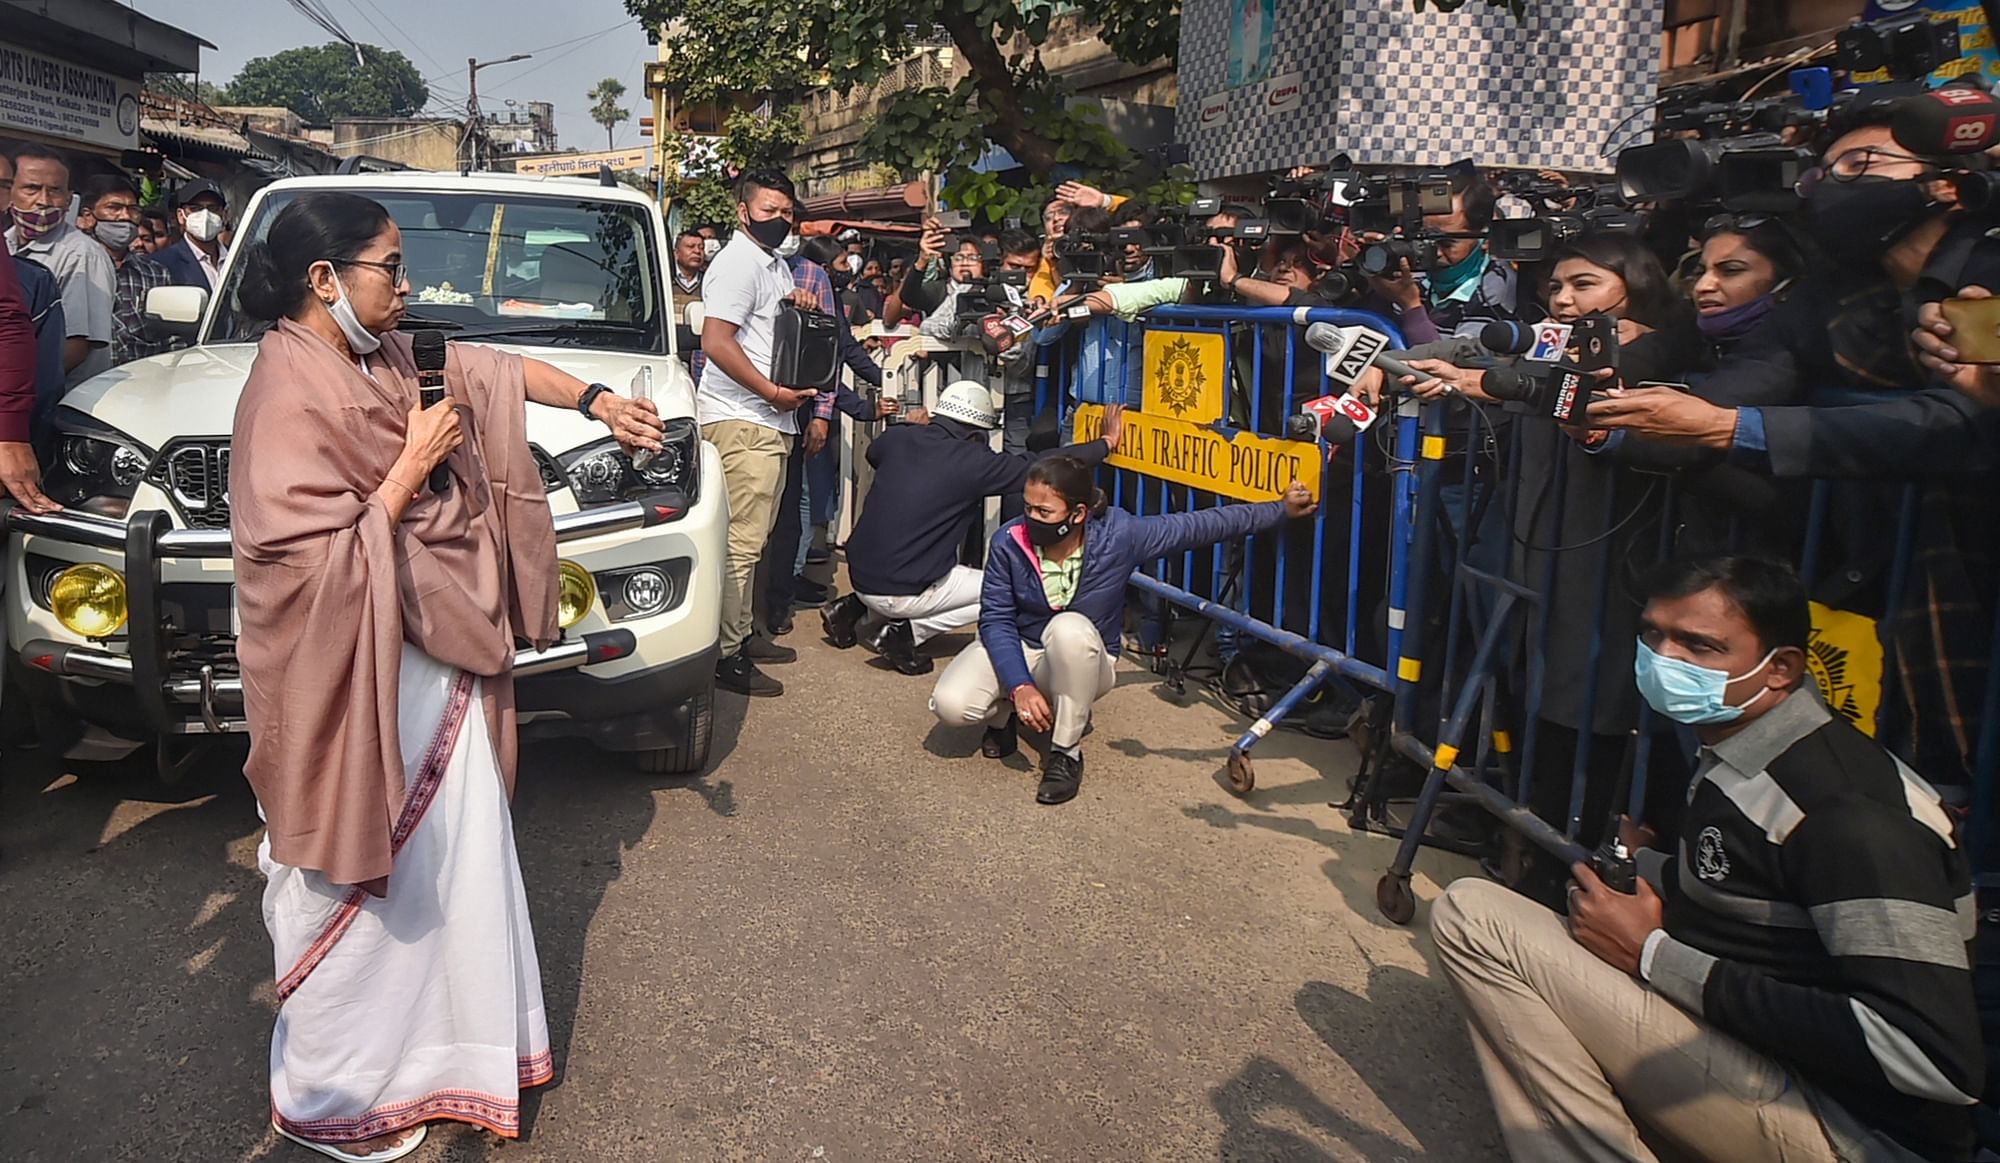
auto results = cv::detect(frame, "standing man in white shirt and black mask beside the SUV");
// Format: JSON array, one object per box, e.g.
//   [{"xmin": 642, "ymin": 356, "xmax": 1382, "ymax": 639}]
[{"xmin": 696, "ymin": 170, "xmax": 816, "ymax": 695}]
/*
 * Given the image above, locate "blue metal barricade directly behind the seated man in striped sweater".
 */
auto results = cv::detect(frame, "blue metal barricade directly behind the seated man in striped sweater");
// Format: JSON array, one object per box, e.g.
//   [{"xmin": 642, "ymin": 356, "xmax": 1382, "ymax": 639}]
[{"xmin": 1376, "ymin": 395, "xmax": 2000, "ymax": 921}]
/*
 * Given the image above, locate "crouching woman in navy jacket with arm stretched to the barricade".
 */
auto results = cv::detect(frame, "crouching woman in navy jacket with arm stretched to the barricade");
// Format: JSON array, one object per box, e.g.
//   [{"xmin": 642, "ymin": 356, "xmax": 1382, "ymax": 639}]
[{"xmin": 930, "ymin": 456, "xmax": 1318, "ymax": 803}]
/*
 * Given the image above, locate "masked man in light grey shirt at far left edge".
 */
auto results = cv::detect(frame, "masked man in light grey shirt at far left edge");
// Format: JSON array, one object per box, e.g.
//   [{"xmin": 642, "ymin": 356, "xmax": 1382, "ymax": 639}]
[{"xmin": 6, "ymin": 146, "xmax": 118, "ymax": 388}]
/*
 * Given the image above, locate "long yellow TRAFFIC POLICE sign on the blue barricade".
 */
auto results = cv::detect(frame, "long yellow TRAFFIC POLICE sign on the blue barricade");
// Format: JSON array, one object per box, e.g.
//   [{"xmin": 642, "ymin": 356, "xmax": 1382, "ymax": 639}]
[{"xmin": 1074, "ymin": 404, "xmax": 1324, "ymax": 502}]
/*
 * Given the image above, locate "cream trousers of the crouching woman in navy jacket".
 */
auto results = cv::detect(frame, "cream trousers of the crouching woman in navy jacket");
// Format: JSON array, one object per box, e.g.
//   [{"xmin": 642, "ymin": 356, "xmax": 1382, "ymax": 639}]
[{"xmin": 930, "ymin": 611, "xmax": 1118, "ymax": 751}]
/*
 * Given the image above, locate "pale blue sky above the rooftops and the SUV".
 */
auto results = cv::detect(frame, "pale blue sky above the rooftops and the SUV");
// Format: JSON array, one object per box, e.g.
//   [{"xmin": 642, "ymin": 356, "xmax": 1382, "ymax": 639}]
[{"xmin": 126, "ymin": 0, "xmax": 654, "ymax": 150}]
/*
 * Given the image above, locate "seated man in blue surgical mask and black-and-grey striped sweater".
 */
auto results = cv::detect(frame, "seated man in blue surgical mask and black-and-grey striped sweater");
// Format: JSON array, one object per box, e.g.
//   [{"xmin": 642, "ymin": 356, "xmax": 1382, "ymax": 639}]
[{"xmin": 1430, "ymin": 558, "xmax": 1984, "ymax": 1163}]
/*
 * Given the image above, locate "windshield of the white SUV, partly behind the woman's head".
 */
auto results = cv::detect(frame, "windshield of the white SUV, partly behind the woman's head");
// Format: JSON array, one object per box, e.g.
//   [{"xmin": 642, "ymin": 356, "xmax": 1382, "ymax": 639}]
[{"xmin": 208, "ymin": 190, "xmax": 666, "ymax": 354}]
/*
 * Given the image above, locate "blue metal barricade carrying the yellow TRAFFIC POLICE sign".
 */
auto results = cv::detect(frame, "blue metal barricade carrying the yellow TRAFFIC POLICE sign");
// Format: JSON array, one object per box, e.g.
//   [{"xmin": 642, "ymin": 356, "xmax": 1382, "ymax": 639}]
[{"xmin": 1038, "ymin": 306, "xmax": 1418, "ymax": 793}]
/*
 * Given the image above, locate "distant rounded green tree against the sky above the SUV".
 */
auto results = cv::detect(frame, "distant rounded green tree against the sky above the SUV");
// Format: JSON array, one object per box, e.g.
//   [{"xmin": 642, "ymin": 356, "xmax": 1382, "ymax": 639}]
[{"xmin": 222, "ymin": 42, "xmax": 430, "ymax": 122}]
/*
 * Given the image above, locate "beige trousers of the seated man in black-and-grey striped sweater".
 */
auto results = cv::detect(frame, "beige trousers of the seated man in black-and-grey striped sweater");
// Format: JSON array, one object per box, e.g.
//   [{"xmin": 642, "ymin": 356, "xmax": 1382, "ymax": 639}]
[{"xmin": 1430, "ymin": 879, "xmax": 1850, "ymax": 1163}]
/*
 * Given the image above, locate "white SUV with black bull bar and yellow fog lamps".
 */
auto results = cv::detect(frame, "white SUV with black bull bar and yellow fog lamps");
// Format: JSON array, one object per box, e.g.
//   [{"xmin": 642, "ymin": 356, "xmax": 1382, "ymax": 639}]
[{"xmin": 4, "ymin": 172, "xmax": 728, "ymax": 773}]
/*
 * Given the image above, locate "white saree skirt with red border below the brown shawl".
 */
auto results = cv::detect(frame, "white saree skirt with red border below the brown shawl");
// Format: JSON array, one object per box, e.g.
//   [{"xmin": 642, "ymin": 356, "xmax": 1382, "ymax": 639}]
[{"xmin": 258, "ymin": 643, "xmax": 554, "ymax": 1143}]
